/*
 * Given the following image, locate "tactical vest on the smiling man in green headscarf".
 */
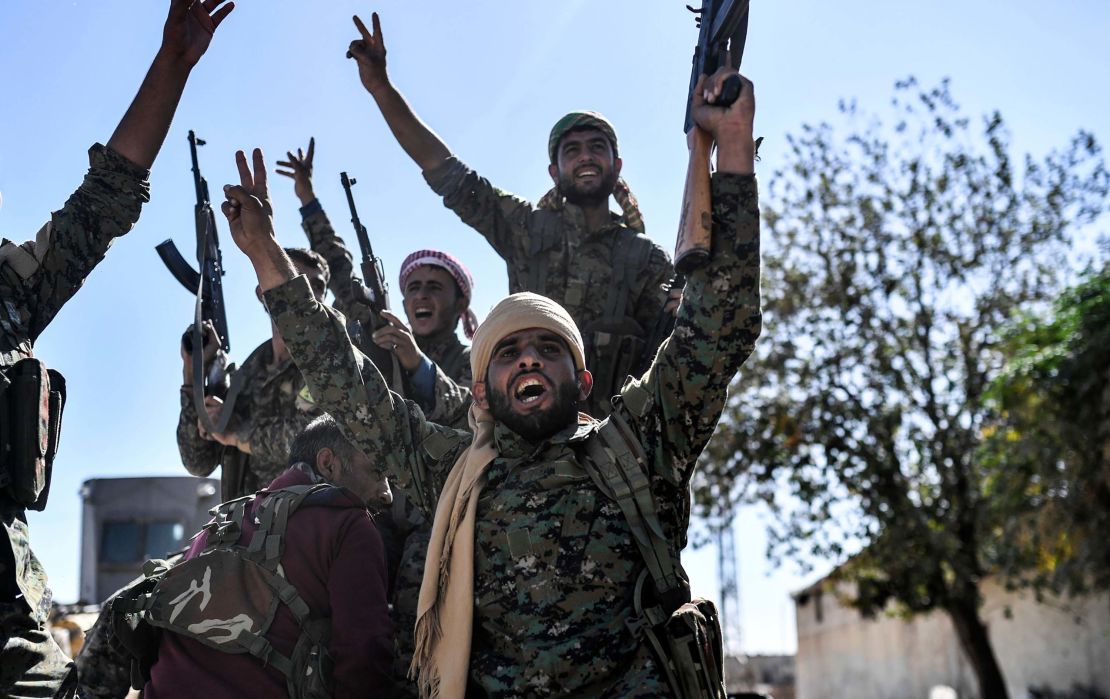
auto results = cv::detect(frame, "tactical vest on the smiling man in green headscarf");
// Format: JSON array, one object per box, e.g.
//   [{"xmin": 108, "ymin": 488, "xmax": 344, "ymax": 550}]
[{"xmin": 522, "ymin": 210, "xmax": 657, "ymax": 417}]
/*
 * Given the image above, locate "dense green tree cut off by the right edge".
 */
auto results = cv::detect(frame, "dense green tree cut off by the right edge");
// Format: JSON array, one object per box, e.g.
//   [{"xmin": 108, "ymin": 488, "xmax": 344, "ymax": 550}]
[{"xmin": 981, "ymin": 266, "xmax": 1110, "ymax": 594}]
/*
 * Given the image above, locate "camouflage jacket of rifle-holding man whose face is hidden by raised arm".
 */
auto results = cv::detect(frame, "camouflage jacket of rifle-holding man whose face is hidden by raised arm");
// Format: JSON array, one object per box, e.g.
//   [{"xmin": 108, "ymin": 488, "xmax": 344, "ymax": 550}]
[{"xmin": 178, "ymin": 340, "xmax": 321, "ymax": 500}]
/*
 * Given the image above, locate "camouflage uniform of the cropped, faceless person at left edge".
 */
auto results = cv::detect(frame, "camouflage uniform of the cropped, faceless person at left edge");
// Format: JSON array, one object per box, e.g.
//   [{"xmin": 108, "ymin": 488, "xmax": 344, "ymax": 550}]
[{"xmin": 0, "ymin": 144, "xmax": 150, "ymax": 697}]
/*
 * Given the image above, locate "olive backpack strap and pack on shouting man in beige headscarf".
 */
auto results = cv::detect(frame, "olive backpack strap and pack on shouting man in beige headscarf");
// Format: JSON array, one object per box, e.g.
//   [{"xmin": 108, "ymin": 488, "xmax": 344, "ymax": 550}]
[{"xmin": 583, "ymin": 396, "xmax": 726, "ymax": 699}]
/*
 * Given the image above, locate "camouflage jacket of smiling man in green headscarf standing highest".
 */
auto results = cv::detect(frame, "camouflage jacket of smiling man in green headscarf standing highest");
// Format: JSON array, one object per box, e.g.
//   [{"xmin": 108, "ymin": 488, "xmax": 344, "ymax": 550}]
[{"xmin": 424, "ymin": 158, "xmax": 674, "ymax": 417}]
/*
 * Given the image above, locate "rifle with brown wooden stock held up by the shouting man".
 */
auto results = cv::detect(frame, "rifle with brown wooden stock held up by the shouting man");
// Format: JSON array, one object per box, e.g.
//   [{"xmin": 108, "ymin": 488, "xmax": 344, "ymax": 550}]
[{"xmin": 675, "ymin": 0, "xmax": 749, "ymax": 274}]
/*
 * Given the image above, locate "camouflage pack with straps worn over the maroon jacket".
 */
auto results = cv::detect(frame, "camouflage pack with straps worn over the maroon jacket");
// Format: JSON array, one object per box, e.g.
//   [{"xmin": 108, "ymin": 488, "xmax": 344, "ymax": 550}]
[{"xmin": 105, "ymin": 485, "xmax": 361, "ymax": 699}]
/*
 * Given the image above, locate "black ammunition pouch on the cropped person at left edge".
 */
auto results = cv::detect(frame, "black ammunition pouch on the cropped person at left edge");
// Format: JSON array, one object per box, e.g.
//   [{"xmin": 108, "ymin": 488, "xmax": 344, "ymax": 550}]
[{"xmin": 0, "ymin": 357, "xmax": 65, "ymax": 510}]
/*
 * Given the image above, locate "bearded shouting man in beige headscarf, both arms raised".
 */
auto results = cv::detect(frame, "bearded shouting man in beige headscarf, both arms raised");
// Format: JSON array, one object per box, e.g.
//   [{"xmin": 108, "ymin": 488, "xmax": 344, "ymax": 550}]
[{"xmin": 223, "ymin": 71, "xmax": 761, "ymax": 699}]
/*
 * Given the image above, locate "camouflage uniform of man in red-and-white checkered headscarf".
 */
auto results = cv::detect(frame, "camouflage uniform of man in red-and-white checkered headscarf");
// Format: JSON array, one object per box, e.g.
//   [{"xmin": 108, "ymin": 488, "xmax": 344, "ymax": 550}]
[{"xmin": 301, "ymin": 200, "xmax": 471, "ymax": 692}]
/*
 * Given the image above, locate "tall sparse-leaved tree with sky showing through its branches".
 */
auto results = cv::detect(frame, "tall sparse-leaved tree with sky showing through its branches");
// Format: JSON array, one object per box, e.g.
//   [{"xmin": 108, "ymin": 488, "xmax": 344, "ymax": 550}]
[{"xmin": 696, "ymin": 79, "xmax": 1110, "ymax": 699}]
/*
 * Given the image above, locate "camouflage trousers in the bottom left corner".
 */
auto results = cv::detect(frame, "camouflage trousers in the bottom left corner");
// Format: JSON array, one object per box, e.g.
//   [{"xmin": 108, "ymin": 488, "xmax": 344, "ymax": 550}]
[{"xmin": 0, "ymin": 604, "xmax": 77, "ymax": 698}]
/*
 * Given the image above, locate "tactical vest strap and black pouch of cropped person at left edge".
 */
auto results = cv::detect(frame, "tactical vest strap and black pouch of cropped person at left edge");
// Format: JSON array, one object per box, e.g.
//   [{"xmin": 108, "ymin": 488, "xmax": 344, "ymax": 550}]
[{"xmin": 0, "ymin": 249, "xmax": 65, "ymax": 510}]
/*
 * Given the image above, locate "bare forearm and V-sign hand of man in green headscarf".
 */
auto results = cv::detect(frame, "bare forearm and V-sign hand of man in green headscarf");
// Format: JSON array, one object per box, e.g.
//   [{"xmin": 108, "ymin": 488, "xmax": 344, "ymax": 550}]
[{"xmin": 347, "ymin": 12, "xmax": 451, "ymax": 171}]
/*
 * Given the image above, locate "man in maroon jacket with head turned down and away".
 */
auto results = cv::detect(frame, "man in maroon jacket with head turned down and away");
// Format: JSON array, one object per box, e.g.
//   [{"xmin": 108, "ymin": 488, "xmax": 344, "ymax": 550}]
[{"xmin": 143, "ymin": 415, "xmax": 393, "ymax": 699}]
